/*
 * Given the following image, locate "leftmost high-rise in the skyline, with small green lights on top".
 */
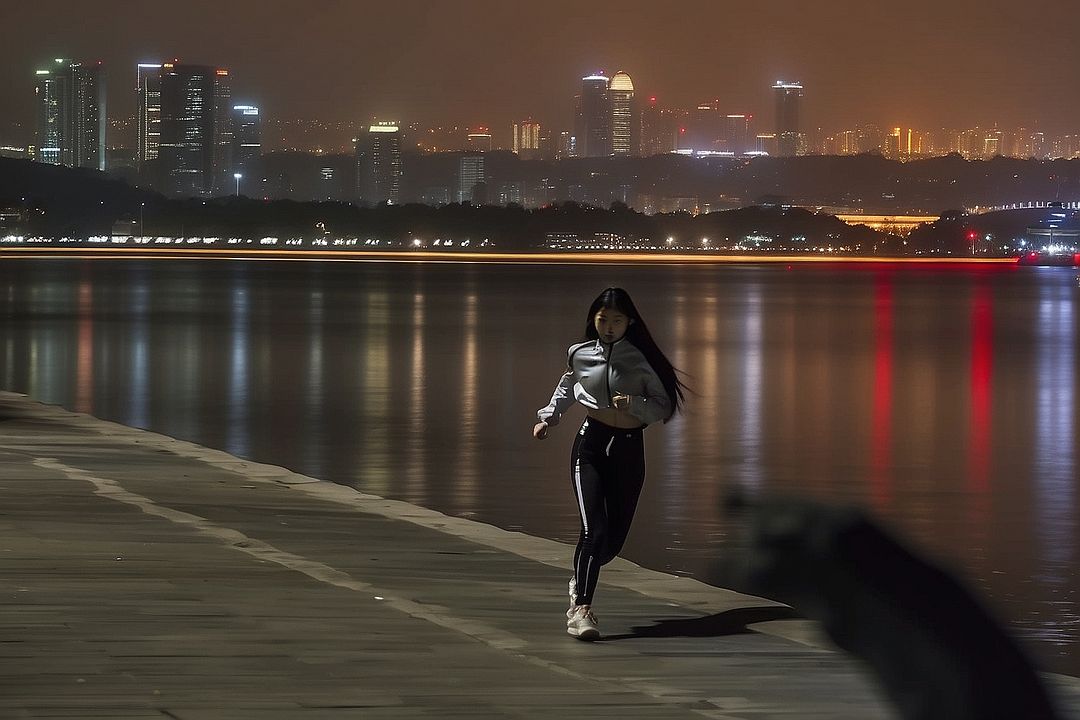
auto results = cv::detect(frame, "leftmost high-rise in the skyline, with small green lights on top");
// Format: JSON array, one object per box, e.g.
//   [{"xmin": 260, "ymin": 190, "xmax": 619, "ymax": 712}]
[{"xmin": 35, "ymin": 58, "xmax": 108, "ymax": 171}]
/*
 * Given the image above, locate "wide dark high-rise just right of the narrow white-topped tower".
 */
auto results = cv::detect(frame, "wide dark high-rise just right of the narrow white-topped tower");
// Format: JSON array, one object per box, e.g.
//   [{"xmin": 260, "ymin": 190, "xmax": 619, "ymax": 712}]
[{"xmin": 153, "ymin": 63, "xmax": 232, "ymax": 196}]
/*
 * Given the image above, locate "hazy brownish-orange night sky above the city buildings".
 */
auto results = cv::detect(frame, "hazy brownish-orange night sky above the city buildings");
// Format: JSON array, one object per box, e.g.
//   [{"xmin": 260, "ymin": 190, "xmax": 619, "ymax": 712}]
[{"xmin": 6, "ymin": 0, "xmax": 1080, "ymax": 141}]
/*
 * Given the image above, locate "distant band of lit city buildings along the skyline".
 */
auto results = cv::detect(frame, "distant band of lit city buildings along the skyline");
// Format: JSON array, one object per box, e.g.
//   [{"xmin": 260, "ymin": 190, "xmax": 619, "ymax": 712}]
[{"xmin": 23, "ymin": 58, "xmax": 1080, "ymax": 167}]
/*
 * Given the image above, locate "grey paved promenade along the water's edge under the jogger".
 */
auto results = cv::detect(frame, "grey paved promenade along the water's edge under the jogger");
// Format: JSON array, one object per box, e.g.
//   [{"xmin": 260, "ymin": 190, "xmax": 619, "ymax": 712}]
[{"xmin": 0, "ymin": 393, "xmax": 1080, "ymax": 720}]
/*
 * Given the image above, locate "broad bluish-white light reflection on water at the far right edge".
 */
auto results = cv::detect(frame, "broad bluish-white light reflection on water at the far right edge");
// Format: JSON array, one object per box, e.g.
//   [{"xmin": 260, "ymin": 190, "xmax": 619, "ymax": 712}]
[{"xmin": 1035, "ymin": 284, "xmax": 1077, "ymax": 584}]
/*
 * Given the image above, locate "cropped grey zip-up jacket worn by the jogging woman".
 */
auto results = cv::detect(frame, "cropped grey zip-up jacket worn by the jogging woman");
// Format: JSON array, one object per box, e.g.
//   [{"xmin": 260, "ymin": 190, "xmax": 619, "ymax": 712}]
[{"xmin": 537, "ymin": 338, "xmax": 672, "ymax": 425}]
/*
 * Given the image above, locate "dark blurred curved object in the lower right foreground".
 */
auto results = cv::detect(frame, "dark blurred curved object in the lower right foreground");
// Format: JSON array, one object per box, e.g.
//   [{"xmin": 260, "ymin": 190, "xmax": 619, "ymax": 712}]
[{"xmin": 725, "ymin": 498, "xmax": 1058, "ymax": 720}]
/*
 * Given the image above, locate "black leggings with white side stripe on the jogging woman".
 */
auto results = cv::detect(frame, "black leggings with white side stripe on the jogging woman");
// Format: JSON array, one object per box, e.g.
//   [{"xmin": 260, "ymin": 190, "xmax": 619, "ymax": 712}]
[{"xmin": 570, "ymin": 418, "xmax": 645, "ymax": 604}]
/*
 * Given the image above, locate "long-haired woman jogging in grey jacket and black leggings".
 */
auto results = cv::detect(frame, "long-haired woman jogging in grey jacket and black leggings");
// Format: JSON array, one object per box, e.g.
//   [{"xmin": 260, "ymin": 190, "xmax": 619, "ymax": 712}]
[{"xmin": 532, "ymin": 287, "xmax": 685, "ymax": 640}]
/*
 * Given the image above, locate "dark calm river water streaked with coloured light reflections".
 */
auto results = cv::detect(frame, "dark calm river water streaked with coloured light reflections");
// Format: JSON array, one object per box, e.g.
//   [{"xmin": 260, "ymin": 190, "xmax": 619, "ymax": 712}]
[{"xmin": 0, "ymin": 259, "xmax": 1080, "ymax": 675}]
